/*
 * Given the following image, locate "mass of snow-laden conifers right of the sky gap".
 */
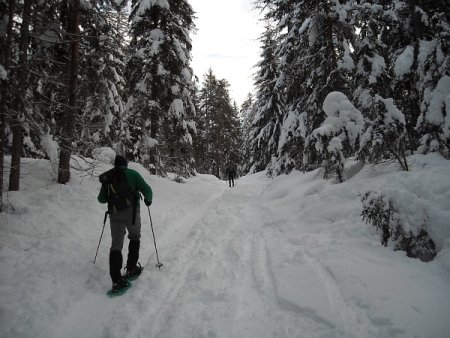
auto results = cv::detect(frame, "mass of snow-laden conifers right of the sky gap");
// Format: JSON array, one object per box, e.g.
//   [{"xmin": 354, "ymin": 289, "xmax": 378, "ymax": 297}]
[{"xmin": 243, "ymin": 0, "xmax": 450, "ymax": 181}]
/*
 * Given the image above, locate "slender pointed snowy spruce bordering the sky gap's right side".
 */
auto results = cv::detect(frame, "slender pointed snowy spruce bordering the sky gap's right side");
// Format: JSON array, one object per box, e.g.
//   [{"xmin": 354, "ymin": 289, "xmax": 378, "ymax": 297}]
[{"xmin": 244, "ymin": 25, "xmax": 284, "ymax": 172}]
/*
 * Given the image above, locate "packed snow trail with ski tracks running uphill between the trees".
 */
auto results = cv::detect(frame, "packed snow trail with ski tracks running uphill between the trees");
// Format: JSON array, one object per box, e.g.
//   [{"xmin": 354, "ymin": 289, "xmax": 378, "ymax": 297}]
[{"xmin": 54, "ymin": 174, "xmax": 369, "ymax": 337}]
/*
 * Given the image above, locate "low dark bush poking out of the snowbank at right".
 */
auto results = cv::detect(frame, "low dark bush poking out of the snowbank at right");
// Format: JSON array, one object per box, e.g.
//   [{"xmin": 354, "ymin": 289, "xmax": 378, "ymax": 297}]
[{"xmin": 361, "ymin": 191, "xmax": 436, "ymax": 262}]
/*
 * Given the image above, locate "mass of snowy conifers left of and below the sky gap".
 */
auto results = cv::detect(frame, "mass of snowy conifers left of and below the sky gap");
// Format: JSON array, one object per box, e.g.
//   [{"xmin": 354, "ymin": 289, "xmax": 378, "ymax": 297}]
[{"xmin": 0, "ymin": 0, "xmax": 242, "ymax": 208}]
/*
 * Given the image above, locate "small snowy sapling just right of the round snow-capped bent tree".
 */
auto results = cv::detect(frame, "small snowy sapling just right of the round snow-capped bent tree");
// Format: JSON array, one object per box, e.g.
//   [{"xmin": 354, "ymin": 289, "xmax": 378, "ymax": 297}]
[{"xmin": 358, "ymin": 95, "xmax": 408, "ymax": 171}]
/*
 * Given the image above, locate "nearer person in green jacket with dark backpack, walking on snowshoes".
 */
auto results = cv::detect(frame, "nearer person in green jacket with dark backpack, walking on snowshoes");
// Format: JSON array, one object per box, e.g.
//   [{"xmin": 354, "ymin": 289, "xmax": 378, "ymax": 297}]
[{"xmin": 98, "ymin": 156, "xmax": 153, "ymax": 293}]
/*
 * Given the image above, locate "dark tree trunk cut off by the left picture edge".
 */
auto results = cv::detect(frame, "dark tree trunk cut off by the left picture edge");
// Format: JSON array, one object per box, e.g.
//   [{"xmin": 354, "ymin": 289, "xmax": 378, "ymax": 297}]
[{"xmin": 0, "ymin": 0, "xmax": 16, "ymax": 212}]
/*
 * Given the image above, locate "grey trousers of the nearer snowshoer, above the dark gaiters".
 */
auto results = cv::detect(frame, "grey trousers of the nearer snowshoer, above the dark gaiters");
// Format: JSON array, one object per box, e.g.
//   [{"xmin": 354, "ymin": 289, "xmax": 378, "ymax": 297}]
[{"xmin": 109, "ymin": 207, "xmax": 141, "ymax": 251}]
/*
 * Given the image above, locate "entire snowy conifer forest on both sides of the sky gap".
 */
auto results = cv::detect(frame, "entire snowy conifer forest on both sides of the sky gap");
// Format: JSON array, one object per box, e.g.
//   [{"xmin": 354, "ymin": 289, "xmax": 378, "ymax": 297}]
[{"xmin": 0, "ymin": 0, "xmax": 450, "ymax": 213}]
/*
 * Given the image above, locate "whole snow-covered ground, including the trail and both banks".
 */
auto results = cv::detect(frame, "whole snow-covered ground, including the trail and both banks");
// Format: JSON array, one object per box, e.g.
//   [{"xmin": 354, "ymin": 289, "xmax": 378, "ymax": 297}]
[{"xmin": 0, "ymin": 154, "xmax": 450, "ymax": 338}]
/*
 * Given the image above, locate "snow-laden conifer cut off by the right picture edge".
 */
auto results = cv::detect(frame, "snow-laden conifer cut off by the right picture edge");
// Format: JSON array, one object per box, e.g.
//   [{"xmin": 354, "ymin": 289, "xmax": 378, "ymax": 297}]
[{"xmin": 414, "ymin": 1, "xmax": 450, "ymax": 158}]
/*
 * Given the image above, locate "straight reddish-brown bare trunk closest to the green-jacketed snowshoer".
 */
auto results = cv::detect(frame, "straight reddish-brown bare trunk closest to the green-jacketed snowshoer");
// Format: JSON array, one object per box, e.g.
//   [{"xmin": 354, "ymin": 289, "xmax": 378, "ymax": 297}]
[{"xmin": 58, "ymin": 0, "xmax": 80, "ymax": 184}]
